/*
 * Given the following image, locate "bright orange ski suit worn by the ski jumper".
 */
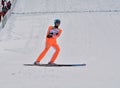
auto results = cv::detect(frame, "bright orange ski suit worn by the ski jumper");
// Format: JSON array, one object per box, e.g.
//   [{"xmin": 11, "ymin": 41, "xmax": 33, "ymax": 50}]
[{"xmin": 36, "ymin": 26, "xmax": 62, "ymax": 63}]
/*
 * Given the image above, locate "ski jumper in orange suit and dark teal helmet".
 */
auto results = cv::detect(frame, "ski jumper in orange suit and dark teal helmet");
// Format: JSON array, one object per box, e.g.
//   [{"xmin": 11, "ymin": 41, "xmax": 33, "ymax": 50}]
[{"xmin": 34, "ymin": 19, "xmax": 62, "ymax": 64}]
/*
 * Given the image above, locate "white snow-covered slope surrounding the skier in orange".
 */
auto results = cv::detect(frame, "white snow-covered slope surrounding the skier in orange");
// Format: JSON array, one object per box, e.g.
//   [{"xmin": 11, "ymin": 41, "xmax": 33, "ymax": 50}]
[{"xmin": 0, "ymin": 0, "xmax": 120, "ymax": 88}]
